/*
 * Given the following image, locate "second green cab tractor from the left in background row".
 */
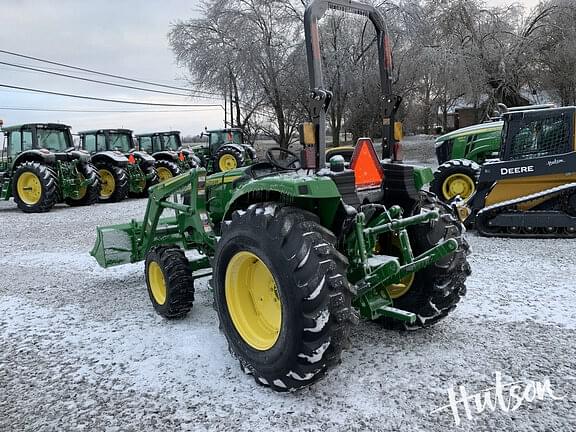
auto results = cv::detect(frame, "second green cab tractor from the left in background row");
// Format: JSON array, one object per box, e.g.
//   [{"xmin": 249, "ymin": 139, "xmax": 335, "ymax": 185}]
[{"xmin": 79, "ymin": 129, "xmax": 159, "ymax": 198}]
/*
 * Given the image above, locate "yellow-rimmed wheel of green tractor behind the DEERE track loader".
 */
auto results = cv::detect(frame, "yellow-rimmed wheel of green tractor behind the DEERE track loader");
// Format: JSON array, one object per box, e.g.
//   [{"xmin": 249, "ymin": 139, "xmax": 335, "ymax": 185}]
[{"xmin": 430, "ymin": 159, "xmax": 480, "ymax": 203}]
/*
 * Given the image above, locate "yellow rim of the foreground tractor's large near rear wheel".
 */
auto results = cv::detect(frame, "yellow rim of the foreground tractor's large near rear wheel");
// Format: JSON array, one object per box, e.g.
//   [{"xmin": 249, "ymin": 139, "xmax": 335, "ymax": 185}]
[{"xmin": 225, "ymin": 252, "xmax": 282, "ymax": 351}]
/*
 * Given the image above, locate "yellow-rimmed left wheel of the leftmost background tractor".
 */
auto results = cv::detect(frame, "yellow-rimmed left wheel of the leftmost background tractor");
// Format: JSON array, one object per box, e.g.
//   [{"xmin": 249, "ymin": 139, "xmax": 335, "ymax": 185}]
[{"xmin": 12, "ymin": 162, "xmax": 58, "ymax": 213}]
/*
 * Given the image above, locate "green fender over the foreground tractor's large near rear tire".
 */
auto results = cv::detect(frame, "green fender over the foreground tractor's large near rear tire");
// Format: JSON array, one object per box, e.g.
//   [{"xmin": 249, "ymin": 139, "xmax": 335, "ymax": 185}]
[{"xmin": 222, "ymin": 173, "xmax": 342, "ymax": 227}]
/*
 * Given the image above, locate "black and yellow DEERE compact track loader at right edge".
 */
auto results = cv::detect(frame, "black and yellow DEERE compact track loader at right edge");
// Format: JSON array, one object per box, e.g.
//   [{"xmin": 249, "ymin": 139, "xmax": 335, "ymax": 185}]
[{"xmin": 459, "ymin": 107, "xmax": 576, "ymax": 238}]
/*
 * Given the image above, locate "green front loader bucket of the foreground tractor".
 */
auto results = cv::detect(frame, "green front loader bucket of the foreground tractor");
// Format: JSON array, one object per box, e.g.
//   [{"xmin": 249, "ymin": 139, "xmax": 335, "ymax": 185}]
[{"xmin": 90, "ymin": 221, "xmax": 140, "ymax": 268}]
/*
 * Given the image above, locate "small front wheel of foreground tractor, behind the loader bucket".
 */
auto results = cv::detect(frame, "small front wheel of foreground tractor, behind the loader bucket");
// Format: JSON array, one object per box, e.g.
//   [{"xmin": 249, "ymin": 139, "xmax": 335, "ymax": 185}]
[{"xmin": 145, "ymin": 246, "xmax": 194, "ymax": 319}]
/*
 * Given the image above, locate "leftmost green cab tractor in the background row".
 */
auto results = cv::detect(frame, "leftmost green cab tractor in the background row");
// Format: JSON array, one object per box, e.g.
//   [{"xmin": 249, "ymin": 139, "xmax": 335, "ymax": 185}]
[{"xmin": 0, "ymin": 124, "xmax": 100, "ymax": 213}]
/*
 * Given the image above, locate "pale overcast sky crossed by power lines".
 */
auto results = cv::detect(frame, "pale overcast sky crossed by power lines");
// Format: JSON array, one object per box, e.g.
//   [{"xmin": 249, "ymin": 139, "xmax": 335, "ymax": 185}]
[{"xmin": 0, "ymin": 0, "xmax": 537, "ymax": 135}]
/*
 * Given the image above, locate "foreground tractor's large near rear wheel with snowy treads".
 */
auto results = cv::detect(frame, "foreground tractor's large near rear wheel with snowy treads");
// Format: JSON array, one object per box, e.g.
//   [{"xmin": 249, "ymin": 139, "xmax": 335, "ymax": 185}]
[{"xmin": 213, "ymin": 203, "xmax": 356, "ymax": 391}]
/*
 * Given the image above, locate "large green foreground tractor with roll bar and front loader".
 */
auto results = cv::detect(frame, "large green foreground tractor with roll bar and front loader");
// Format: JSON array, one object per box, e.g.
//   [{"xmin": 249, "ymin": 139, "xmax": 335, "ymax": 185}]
[{"xmin": 91, "ymin": 0, "xmax": 470, "ymax": 391}]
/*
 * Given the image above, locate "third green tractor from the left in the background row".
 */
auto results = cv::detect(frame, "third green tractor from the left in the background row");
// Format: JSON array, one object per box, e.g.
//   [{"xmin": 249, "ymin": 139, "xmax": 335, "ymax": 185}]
[{"xmin": 136, "ymin": 131, "xmax": 200, "ymax": 181}]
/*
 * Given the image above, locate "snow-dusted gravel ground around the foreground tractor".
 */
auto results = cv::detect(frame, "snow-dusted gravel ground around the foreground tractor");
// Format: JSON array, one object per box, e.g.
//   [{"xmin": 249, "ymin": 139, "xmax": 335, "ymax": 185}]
[{"xmin": 0, "ymin": 141, "xmax": 576, "ymax": 432}]
